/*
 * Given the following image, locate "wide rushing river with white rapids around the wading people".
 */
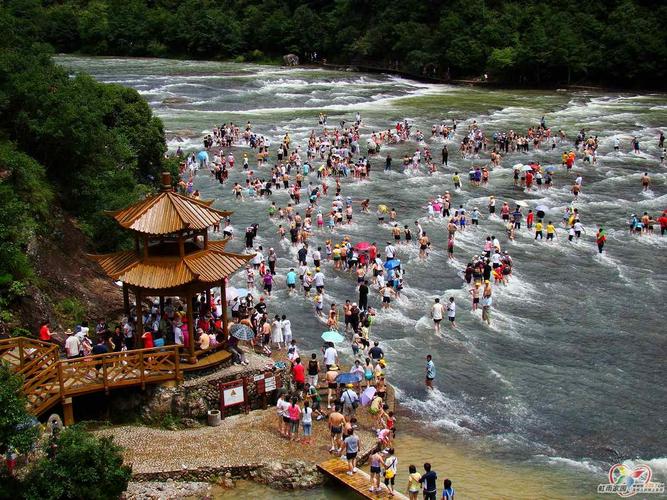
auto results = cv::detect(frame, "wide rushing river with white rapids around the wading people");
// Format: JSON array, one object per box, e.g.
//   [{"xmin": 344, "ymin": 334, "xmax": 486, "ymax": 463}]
[{"xmin": 58, "ymin": 56, "xmax": 667, "ymax": 498}]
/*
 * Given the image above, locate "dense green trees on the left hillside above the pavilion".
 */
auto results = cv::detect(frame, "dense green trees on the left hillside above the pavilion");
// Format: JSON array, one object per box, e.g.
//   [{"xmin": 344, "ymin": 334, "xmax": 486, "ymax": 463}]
[{"xmin": 0, "ymin": 2, "xmax": 174, "ymax": 330}]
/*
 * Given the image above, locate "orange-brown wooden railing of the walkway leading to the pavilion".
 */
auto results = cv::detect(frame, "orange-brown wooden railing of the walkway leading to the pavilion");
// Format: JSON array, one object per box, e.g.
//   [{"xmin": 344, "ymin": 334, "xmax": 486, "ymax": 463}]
[{"xmin": 0, "ymin": 337, "xmax": 182, "ymax": 415}]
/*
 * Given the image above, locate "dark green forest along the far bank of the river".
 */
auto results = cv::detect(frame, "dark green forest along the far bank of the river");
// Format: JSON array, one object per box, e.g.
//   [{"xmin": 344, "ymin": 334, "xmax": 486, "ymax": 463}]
[{"xmin": 9, "ymin": 0, "xmax": 667, "ymax": 87}]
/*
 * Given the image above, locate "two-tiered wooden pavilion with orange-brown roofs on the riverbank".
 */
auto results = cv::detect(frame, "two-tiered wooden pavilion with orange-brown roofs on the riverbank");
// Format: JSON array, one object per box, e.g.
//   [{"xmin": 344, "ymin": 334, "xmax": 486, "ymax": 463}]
[{"xmin": 91, "ymin": 173, "xmax": 253, "ymax": 363}]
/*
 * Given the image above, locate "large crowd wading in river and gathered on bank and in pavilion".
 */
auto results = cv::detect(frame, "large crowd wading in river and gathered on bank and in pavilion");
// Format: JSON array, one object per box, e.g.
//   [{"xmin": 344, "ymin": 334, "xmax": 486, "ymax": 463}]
[{"xmin": 40, "ymin": 103, "xmax": 667, "ymax": 498}]
